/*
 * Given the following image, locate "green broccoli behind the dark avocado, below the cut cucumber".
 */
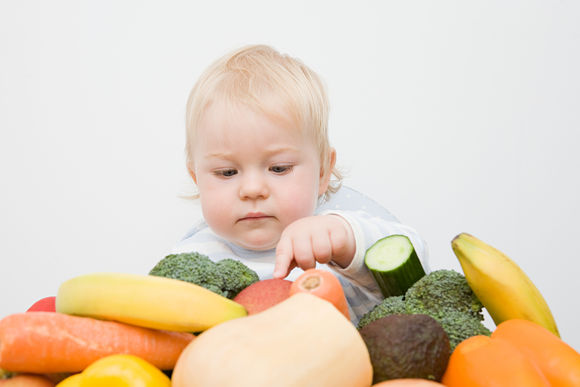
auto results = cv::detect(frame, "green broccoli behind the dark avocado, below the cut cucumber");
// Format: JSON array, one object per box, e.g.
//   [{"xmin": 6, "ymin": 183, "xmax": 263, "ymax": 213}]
[{"xmin": 358, "ymin": 270, "xmax": 491, "ymax": 350}]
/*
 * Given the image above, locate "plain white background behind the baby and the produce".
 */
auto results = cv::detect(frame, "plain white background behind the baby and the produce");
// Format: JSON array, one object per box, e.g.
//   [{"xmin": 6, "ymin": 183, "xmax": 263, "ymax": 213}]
[{"xmin": 0, "ymin": 0, "xmax": 580, "ymax": 350}]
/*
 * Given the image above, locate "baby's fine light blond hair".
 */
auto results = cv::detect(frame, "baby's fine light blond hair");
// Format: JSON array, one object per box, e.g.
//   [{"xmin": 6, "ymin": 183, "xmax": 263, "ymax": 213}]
[{"xmin": 186, "ymin": 45, "xmax": 342, "ymax": 199}]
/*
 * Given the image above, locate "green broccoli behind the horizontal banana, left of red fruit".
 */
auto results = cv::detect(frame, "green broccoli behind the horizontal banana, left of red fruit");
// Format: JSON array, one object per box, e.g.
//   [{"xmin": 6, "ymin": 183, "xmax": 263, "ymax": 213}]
[{"xmin": 149, "ymin": 252, "xmax": 259, "ymax": 298}]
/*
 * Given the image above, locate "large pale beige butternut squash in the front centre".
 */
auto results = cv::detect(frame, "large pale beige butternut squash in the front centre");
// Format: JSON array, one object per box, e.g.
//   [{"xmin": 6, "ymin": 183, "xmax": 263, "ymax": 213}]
[{"xmin": 172, "ymin": 293, "xmax": 373, "ymax": 387}]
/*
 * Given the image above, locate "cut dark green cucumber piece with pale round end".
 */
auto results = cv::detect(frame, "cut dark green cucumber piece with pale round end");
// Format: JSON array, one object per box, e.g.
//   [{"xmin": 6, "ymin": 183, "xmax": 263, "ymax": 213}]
[{"xmin": 365, "ymin": 235, "xmax": 425, "ymax": 298}]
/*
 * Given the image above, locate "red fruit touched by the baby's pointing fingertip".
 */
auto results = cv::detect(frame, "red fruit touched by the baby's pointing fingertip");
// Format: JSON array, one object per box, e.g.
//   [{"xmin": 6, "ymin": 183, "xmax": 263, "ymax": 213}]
[{"xmin": 234, "ymin": 278, "xmax": 292, "ymax": 314}]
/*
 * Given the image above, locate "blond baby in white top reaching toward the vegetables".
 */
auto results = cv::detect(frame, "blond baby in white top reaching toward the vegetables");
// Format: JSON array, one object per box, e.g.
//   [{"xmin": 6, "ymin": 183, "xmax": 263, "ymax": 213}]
[{"xmin": 173, "ymin": 45, "xmax": 426, "ymax": 322}]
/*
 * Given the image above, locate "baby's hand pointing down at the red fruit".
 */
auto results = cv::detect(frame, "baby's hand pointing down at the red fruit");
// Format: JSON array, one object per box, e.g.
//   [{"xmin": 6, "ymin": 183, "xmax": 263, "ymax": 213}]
[{"xmin": 274, "ymin": 215, "xmax": 356, "ymax": 278}]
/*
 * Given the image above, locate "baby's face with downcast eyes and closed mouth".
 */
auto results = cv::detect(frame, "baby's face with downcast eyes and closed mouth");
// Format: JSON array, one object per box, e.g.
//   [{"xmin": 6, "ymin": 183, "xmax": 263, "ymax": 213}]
[{"xmin": 190, "ymin": 103, "xmax": 329, "ymax": 250}]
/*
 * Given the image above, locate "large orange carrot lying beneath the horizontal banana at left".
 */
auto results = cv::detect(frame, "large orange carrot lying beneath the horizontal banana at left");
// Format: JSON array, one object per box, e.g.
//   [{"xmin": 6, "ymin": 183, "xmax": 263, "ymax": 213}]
[{"xmin": 0, "ymin": 312, "xmax": 194, "ymax": 374}]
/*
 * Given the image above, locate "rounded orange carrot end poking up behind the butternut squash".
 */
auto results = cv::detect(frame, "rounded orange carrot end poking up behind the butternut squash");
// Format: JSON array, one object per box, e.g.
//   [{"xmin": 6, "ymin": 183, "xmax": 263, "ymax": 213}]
[{"xmin": 290, "ymin": 269, "xmax": 350, "ymax": 319}]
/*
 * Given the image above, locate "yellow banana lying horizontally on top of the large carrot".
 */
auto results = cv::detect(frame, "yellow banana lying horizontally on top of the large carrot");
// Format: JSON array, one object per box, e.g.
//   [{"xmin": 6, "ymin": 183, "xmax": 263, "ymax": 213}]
[{"xmin": 56, "ymin": 273, "xmax": 247, "ymax": 332}]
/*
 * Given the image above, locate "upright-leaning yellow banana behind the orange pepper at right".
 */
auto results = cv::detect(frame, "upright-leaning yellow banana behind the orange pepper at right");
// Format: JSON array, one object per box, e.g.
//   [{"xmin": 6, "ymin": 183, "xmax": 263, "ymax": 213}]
[{"xmin": 451, "ymin": 233, "xmax": 560, "ymax": 337}]
